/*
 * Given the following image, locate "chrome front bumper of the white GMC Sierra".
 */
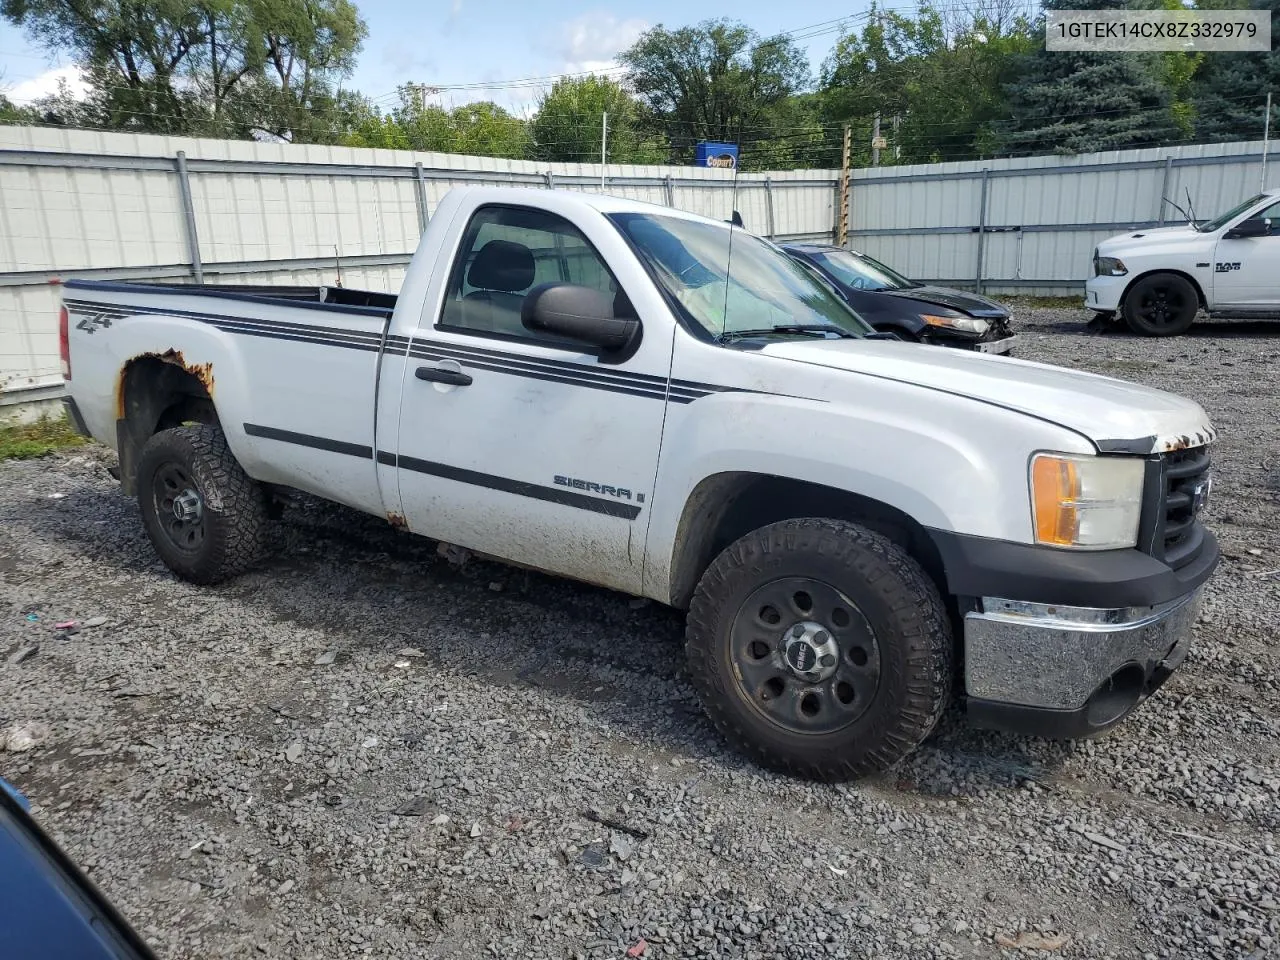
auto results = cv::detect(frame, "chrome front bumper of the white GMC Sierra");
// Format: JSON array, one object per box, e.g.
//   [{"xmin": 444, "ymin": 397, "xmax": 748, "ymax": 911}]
[{"xmin": 964, "ymin": 589, "xmax": 1203, "ymax": 730}]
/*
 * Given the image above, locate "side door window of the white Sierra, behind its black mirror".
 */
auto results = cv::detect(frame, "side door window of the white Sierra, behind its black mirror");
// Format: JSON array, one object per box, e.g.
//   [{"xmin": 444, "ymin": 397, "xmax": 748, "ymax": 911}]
[{"xmin": 439, "ymin": 206, "xmax": 630, "ymax": 342}]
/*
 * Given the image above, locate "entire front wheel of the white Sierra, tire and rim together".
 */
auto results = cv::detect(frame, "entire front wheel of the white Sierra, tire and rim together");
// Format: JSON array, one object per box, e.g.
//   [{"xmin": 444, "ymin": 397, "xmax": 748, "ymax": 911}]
[{"xmin": 686, "ymin": 518, "xmax": 952, "ymax": 781}]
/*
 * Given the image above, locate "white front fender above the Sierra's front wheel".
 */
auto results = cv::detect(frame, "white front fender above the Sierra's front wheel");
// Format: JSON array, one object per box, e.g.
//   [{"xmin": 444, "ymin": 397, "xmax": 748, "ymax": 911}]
[{"xmin": 645, "ymin": 381, "xmax": 1093, "ymax": 596}]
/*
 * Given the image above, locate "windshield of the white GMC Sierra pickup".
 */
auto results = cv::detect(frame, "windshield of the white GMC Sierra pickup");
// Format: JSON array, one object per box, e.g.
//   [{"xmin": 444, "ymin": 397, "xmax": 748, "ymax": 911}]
[{"xmin": 612, "ymin": 214, "xmax": 872, "ymax": 337}]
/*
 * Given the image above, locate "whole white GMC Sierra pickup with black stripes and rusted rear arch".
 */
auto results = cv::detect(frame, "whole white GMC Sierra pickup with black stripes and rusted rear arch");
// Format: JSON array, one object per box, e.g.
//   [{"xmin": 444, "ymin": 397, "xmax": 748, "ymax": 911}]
[{"xmin": 61, "ymin": 187, "xmax": 1219, "ymax": 780}]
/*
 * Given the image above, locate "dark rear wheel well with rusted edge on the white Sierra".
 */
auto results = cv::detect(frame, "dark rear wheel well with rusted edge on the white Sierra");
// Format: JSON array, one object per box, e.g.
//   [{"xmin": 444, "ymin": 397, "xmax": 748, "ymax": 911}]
[{"xmin": 115, "ymin": 351, "xmax": 218, "ymax": 494}]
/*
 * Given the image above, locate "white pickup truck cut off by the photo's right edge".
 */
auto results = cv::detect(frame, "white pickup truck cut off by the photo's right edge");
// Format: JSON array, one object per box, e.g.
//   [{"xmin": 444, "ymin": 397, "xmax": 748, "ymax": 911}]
[{"xmin": 1084, "ymin": 191, "xmax": 1280, "ymax": 337}]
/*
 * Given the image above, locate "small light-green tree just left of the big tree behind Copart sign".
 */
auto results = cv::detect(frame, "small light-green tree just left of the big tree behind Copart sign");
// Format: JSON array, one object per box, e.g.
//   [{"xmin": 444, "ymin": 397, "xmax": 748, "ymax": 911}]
[{"xmin": 530, "ymin": 77, "xmax": 667, "ymax": 164}]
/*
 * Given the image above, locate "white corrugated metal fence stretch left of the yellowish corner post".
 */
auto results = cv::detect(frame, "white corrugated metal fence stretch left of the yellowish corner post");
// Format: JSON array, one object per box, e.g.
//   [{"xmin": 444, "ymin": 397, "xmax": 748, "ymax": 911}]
[{"xmin": 0, "ymin": 127, "xmax": 838, "ymax": 403}]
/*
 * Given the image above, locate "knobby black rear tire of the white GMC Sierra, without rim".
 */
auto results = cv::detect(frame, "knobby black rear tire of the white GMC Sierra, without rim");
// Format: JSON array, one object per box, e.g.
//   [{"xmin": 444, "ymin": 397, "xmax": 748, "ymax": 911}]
[{"xmin": 137, "ymin": 424, "xmax": 271, "ymax": 584}]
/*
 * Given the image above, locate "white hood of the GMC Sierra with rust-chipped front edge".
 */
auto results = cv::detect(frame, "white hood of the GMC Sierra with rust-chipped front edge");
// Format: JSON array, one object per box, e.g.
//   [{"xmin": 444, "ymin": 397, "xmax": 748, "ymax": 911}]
[{"xmin": 762, "ymin": 339, "xmax": 1215, "ymax": 453}]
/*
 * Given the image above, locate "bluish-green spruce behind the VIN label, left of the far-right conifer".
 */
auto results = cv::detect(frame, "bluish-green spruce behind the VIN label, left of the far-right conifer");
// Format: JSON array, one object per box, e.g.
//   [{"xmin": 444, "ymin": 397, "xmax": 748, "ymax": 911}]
[{"xmin": 998, "ymin": 0, "xmax": 1180, "ymax": 154}]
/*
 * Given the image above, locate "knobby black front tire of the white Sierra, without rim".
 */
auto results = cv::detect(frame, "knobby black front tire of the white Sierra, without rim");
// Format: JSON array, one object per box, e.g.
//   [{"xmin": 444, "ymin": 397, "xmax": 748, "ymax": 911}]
[{"xmin": 685, "ymin": 518, "xmax": 954, "ymax": 782}]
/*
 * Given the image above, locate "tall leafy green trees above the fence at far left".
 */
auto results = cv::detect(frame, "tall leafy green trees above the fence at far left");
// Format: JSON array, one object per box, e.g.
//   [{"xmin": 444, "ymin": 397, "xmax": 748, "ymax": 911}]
[{"xmin": 0, "ymin": 0, "xmax": 366, "ymax": 141}]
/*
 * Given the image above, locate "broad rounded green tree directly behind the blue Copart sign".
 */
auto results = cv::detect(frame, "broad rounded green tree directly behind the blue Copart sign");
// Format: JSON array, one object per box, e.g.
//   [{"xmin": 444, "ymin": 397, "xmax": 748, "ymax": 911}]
[{"xmin": 618, "ymin": 19, "xmax": 809, "ymax": 168}]
